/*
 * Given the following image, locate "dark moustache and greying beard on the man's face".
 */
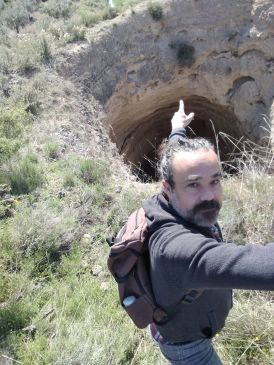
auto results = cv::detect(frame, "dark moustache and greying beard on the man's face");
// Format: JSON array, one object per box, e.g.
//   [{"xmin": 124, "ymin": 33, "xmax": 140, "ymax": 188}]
[{"xmin": 170, "ymin": 192, "xmax": 221, "ymax": 227}]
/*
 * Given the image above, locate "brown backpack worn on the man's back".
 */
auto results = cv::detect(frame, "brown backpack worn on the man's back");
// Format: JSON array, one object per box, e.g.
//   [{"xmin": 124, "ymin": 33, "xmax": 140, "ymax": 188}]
[{"xmin": 107, "ymin": 208, "xmax": 202, "ymax": 328}]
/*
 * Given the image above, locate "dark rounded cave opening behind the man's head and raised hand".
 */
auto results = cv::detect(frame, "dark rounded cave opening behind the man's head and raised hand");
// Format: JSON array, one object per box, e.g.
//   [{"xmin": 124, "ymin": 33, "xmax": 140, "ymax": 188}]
[{"xmin": 108, "ymin": 96, "xmax": 243, "ymax": 181}]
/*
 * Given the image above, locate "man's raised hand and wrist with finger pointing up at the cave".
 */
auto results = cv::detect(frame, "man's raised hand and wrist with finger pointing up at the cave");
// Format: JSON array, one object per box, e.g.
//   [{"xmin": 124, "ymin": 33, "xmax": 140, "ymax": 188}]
[{"xmin": 169, "ymin": 99, "xmax": 194, "ymax": 144}]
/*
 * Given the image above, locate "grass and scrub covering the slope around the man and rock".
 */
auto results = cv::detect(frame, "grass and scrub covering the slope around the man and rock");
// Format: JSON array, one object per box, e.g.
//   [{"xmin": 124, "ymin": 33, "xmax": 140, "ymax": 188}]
[{"xmin": 0, "ymin": 0, "xmax": 274, "ymax": 365}]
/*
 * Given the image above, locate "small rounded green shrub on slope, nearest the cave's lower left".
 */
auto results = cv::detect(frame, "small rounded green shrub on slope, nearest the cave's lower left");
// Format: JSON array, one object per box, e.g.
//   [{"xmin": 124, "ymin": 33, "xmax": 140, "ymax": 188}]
[{"xmin": 80, "ymin": 159, "xmax": 110, "ymax": 184}]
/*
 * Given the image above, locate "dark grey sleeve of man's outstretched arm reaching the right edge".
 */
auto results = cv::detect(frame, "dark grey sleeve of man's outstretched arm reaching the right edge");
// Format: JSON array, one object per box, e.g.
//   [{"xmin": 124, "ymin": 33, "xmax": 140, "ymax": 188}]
[{"xmin": 156, "ymin": 232, "xmax": 274, "ymax": 290}]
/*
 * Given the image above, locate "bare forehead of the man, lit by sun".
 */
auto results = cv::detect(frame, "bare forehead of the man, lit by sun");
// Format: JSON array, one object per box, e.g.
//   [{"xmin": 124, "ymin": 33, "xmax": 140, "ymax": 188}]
[{"xmin": 172, "ymin": 149, "xmax": 221, "ymax": 178}]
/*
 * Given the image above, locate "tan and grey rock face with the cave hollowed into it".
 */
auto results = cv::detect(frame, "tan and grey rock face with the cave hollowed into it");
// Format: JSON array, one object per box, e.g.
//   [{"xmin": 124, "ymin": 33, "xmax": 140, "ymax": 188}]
[{"xmin": 61, "ymin": 0, "xmax": 274, "ymax": 176}]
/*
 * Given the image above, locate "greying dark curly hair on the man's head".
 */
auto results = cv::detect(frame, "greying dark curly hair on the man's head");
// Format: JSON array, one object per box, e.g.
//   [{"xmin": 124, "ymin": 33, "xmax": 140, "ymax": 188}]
[{"xmin": 158, "ymin": 138, "xmax": 215, "ymax": 188}]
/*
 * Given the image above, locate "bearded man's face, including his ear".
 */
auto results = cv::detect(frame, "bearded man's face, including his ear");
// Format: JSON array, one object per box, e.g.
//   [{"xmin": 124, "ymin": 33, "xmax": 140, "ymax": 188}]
[{"xmin": 163, "ymin": 149, "xmax": 223, "ymax": 227}]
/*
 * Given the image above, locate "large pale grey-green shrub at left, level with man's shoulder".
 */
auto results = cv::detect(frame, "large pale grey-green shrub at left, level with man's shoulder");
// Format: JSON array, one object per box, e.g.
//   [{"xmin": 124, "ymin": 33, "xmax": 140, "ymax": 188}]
[{"xmin": 12, "ymin": 202, "xmax": 81, "ymax": 258}]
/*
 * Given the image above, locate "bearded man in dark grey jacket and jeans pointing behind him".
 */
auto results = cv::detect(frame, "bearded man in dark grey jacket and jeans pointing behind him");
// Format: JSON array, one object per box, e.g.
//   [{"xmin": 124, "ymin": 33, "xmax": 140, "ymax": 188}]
[{"xmin": 144, "ymin": 101, "xmax": 274, "ymax": 365}]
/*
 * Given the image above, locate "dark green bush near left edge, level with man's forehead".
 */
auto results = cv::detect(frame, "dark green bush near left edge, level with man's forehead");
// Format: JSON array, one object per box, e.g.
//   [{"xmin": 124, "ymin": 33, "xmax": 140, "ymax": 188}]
[{"xmin": 8, "ymin": 155, "xmax": 43, "ymax": 194}]
